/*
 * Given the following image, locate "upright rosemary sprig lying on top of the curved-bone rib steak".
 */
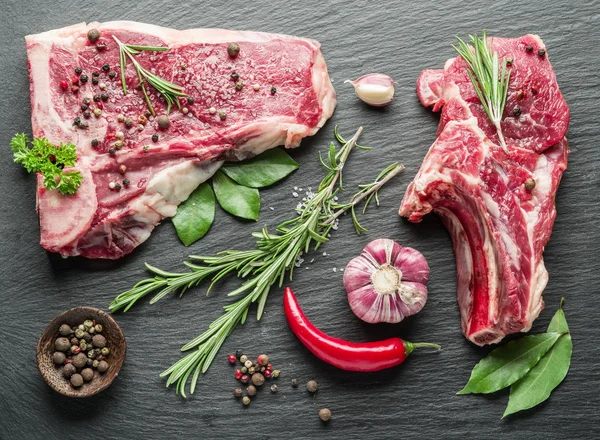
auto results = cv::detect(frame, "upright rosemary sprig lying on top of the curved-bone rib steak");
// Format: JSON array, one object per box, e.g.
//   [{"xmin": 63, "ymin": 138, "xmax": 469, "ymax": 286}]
[{"xmin": 452, "ymin": 30, "xmax": 510, "ymax": 151}]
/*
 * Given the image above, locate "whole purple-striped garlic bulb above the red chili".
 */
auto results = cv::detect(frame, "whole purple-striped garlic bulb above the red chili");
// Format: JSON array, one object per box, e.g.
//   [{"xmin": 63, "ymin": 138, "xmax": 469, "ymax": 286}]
[{"xmin": 344, "ymin": 238, "xmax": 429, "ymax": 323}]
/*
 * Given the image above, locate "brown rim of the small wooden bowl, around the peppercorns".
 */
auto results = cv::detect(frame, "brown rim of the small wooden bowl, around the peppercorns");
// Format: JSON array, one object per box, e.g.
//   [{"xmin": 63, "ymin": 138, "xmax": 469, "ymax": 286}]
[{"xmin": 36, "ymin": 306, "xmax": 127, "ymax": 398}]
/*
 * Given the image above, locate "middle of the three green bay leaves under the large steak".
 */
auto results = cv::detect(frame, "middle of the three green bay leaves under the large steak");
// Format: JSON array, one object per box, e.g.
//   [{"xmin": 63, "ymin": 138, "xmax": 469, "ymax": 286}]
[{"xmin": 213, "ymin": 170, "xmax": 260, "ymax": 220}]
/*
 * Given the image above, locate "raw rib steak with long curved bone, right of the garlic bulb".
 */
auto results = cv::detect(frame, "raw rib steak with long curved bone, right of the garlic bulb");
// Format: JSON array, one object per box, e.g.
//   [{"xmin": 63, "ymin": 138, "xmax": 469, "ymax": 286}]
[{"xmin": 400, "ymin": 35, "xmax": 569, "ymax": 345}]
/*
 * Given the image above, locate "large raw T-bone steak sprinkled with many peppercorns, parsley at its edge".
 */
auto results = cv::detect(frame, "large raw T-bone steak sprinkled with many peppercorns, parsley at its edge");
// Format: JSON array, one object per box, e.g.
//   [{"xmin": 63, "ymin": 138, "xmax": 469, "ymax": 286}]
[{"xmin": 26, "ymin": 22, "xmax": 336, "ymax": 258}]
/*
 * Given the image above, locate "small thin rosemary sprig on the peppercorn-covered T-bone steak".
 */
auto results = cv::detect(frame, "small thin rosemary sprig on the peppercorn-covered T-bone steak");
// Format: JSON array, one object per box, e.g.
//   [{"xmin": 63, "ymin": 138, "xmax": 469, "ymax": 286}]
[{"xmin": 113, "ymin": 35, "xmax": 188, "ymax": 115}]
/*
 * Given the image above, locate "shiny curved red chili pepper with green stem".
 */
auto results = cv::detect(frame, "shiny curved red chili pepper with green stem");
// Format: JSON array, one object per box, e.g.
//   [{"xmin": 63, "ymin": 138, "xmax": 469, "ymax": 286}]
[{"xmin": 283, "ymin": 287, "xmax": 440, "ymax": 372}]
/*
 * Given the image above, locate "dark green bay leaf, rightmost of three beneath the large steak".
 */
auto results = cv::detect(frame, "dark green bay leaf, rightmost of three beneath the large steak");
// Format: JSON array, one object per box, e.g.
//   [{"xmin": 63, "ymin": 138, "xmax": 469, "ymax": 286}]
[{"xmin": 221, "ymin": 148, "xmax": 298, "ymax": 188}]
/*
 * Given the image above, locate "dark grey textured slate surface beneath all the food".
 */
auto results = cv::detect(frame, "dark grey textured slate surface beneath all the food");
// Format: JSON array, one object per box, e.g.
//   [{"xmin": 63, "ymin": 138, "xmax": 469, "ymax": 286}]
[{"xmin": 0, "ymin": 0, "xmax": 600, "ymax": 440}]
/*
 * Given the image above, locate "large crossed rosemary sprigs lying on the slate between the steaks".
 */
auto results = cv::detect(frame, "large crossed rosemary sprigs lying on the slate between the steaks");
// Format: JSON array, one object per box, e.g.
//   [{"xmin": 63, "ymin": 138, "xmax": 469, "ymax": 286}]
[{"xmin": 110, "ymin": 127, "xmax": 404, "ymax": 397}]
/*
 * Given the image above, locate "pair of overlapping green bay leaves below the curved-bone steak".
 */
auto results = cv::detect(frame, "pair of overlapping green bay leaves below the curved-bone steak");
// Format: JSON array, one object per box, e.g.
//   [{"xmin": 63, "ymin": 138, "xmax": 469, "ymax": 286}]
[{"xmin": 458, "ymin": 299, "xmax": 573, "ymax": 417}]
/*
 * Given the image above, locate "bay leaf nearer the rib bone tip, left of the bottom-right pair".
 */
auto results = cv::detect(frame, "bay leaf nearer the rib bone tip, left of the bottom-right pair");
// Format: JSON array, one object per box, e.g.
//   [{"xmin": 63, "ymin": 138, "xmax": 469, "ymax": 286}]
[{"xmin": 458, "ymin": 332, "xmax": 561, "ymax": 394}]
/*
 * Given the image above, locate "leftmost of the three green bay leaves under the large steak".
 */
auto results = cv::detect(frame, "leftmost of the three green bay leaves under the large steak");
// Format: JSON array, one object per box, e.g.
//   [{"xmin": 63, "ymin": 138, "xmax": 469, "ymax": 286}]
[{"xmin": 171, "ymin": 183, "xmax": 215, "ymax": 246}]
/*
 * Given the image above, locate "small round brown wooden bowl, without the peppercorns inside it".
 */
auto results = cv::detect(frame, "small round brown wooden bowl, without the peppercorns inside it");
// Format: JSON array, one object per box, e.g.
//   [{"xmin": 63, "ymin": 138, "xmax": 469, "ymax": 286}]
[{"xmin": 37, "ymin": 307, "xmax": 127, "ymax": 397}]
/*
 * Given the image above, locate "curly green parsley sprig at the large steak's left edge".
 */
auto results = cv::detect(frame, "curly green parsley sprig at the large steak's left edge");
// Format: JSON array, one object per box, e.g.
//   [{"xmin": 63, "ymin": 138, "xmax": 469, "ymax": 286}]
[{"xmin": 10, "ymin": 133, "xmax": 83, "ymax": 195}]
